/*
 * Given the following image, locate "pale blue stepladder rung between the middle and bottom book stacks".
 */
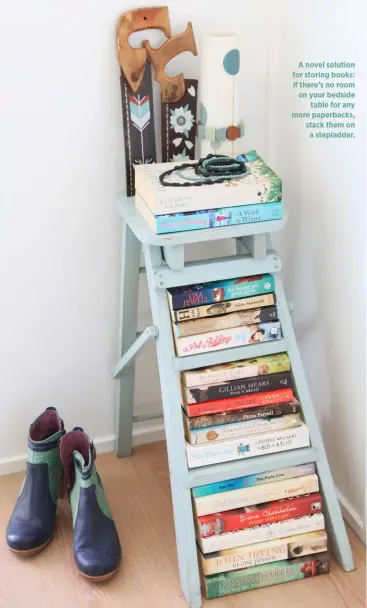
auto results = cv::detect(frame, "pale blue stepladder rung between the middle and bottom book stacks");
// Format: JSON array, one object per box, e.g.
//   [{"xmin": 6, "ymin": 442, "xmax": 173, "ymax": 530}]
[{"xmin": 188, "ymin": 447, "xmax": 318, "ymax": 488}]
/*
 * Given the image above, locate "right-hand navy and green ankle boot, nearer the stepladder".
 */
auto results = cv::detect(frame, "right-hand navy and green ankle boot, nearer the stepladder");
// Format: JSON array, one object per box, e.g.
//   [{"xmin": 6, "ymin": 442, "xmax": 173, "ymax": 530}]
[{"xmin": 60, "ymin": 427, "xmax": 121, "ymax": 582}]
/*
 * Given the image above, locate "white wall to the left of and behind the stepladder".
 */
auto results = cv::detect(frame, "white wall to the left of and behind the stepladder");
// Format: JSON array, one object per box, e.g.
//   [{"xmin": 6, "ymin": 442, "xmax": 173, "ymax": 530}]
[{"xmin": 0, "ymin": 0, "xmax": 267, "ymax": 473}]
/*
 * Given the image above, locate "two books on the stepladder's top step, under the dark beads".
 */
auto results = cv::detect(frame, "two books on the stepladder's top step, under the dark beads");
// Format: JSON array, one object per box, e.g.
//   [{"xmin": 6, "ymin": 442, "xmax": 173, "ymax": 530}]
[{"xmin": 134, "ymin": 150, "xmax": 283, "ymax": 234}]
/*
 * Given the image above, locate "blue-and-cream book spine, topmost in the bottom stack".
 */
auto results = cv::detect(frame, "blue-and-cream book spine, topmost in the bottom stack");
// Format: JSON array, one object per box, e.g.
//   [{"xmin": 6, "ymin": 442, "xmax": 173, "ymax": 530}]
[{"xmin": 192, "ymin": 462, "xmax": 316, "ymax": 498}]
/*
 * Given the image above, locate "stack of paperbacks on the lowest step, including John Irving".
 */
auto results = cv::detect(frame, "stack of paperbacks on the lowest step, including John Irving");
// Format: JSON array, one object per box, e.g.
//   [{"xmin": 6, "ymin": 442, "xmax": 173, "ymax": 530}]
[{"xmin": 196, "ymin": 464, "xmax": 330, "ymax": 599}]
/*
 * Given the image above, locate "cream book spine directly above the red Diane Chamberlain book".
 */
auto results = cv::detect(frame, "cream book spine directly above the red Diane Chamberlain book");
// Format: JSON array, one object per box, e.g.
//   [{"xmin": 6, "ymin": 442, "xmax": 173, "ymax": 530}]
[{"xmin": 194, "ymin": 472, "xmax": 319, "ymax": 517}]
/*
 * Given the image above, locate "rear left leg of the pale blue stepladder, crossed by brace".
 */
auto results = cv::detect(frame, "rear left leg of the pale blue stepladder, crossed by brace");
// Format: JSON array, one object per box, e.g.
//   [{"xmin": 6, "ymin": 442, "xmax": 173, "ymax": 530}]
[{"xmin": 116, "ymin": 222, "xmax": 141, "ymax": 457}]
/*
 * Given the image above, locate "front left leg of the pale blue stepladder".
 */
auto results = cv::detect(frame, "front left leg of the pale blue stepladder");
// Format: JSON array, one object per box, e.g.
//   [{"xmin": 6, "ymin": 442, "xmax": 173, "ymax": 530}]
[{"xmin": 144, "ymin": 247, "xmax": 201, "ymax": 608}]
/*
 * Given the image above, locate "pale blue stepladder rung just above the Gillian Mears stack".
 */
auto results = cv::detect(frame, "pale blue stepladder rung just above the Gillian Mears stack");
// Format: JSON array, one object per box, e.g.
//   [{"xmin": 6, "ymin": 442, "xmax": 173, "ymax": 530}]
[{"xmin": 173, "ymin": 338, "xmax": 288, "ymax": 372}]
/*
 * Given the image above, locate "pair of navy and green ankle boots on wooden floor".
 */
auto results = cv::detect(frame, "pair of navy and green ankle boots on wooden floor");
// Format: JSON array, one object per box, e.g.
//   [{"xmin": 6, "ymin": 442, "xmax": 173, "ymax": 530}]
[{"xmin": 6, "ymin": 407, "xmax": 121, "ymax": 581}]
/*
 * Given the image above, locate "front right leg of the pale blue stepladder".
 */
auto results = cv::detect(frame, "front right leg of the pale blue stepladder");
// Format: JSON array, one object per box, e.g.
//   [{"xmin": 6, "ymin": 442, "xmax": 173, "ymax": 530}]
[{"xmin": 276, "ymin": 276, "xmax": 355, "ymax": 571}]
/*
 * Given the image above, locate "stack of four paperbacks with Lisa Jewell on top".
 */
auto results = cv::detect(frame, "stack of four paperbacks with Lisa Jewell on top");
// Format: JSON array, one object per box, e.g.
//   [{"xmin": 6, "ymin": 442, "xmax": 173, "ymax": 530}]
[{"xmin": 167, "ymin": 274, "xmax": 281, "ymax": 357}]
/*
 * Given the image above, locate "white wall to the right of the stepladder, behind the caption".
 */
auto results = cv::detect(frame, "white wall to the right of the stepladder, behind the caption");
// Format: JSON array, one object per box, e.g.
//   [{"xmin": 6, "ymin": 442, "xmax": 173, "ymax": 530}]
[{"xmin": 268, "ymin": 0, "xmax": 366, "ymax": 536}]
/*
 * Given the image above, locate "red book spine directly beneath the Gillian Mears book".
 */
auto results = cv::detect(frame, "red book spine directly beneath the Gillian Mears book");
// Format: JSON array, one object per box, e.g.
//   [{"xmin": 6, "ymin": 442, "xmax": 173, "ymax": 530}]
[{"xmin": 184, "ymin": 388, "xmax": 294, "ymax": 418}]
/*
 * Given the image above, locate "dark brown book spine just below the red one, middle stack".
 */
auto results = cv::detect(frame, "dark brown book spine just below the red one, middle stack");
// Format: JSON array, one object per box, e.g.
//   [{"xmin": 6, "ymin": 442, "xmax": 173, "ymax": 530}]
[{"xmin": 184, "ymin": 400, "xmax": 301, "ymax": 431}]
